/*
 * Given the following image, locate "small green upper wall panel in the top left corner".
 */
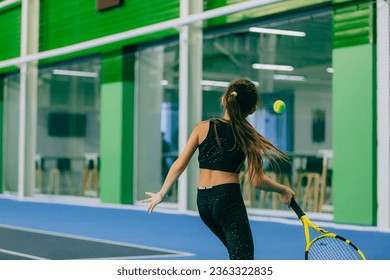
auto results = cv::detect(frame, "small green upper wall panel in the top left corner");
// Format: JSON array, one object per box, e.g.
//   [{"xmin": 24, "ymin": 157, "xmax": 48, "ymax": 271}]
[{"xmin": 0, "ymin": 5, "xmax": 21, "ymax": 61}]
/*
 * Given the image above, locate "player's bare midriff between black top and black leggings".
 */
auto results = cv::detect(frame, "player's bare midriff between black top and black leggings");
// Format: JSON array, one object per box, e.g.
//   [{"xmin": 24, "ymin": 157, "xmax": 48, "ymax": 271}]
[{"xmin": 198, "ymin": 168, "xmax": 240, "ymax": 187}]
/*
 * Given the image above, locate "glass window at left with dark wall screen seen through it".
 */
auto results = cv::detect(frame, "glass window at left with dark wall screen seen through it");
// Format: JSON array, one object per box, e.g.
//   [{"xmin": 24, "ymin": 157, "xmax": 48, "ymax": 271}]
[{"xmin": 36, "ymin": 58, "xmax": 100, "ymax": 196}]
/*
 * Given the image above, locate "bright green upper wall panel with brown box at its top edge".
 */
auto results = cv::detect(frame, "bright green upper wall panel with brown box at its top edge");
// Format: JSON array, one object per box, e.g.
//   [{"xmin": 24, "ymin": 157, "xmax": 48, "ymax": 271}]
[{"xmin": 40, "ymin": 0, "xmax": 180, "ymax": 51}]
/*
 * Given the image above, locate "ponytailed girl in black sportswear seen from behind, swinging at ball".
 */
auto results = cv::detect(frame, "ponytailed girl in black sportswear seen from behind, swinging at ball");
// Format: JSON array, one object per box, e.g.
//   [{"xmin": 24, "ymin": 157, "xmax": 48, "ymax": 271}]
[{"xmin": 142, "ymin": 79, "xmax": 294, "ymax": 260}]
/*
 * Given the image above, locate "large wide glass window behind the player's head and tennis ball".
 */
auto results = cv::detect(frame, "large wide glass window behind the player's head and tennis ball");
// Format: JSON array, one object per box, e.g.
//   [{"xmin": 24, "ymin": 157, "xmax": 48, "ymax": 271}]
[{"xmin": 202, "ymin": 11, "xmax": 332, "ymax": 211}]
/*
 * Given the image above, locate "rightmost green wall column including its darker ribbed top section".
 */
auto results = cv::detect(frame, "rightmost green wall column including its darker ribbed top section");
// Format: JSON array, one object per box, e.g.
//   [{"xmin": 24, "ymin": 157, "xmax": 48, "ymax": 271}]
[{"xmin": 332, "ymin": 1, "xmax": 377, "ymax": 225}]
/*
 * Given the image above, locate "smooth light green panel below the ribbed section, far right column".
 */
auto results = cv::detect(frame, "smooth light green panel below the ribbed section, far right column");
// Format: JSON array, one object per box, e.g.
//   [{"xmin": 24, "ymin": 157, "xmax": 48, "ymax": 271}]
[{"xmin": 332, "ymin": 44, "xmax": 376, "ymax": 225}]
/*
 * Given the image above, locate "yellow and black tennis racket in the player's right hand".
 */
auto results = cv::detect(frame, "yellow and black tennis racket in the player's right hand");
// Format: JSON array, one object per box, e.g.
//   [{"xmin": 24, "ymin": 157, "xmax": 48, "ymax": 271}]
[{"xmin": 290, "ymin": 197, "xmax": 366, "ymax": 260}]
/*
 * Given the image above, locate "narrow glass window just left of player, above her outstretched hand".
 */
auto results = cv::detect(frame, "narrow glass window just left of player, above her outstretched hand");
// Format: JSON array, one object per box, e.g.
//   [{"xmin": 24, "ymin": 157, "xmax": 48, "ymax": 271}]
[{"xmin": 135, "ymin": 43, "xmax": 179, "ymax": 202}]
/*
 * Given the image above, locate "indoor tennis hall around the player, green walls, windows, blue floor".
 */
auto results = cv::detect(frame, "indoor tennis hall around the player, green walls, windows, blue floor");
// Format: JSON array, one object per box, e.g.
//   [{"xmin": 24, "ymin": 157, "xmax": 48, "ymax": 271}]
[{"xmin": 0, "ymin": 0, "xmax": 390, "ymax": 260}]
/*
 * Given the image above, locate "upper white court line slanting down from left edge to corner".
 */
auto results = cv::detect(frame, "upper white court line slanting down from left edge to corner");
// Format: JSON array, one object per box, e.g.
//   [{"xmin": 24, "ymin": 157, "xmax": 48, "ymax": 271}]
[{"xmin": 0, "ymin": 224, "xmax": 195, "ymax": 259}]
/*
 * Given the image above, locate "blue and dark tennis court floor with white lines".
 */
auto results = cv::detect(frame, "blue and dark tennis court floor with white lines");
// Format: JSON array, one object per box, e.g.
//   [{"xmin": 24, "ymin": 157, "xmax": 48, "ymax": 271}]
[{"xmin": 0, "ymin": 197, "xmax": 390, "ymax": 260}]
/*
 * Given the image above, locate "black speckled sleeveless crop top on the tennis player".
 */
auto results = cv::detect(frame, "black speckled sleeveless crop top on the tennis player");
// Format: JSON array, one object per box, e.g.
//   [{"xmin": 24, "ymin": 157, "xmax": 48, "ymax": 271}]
[{"xmin": 198, "ymin": 120, "xmax": 245, "ymax": 173}]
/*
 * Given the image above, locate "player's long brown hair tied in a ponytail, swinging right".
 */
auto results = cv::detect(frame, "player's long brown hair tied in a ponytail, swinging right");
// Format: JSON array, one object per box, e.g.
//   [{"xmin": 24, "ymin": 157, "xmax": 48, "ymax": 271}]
[{"xmin": 222, "ymin": 79, "xmax": 287, "ymax": 183}]
